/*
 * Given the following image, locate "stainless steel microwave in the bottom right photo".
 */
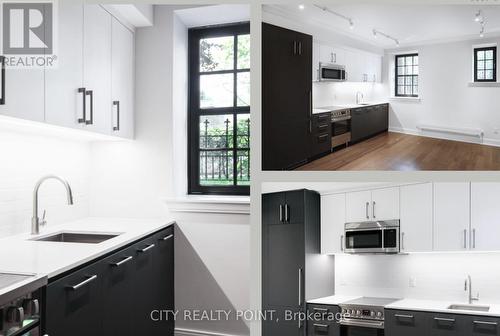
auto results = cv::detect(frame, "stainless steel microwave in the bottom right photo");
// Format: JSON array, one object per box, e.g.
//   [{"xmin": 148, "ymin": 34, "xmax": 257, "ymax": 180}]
[{"xmin": 344, "ymin": 220, "xmax": 400, "ymax": 253}]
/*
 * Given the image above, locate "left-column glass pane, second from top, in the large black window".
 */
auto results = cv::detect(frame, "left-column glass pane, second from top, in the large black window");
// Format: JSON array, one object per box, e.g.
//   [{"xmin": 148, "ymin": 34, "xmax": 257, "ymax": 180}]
[{"xmin": 200, "ymin": 74, "xmax": 234, "ymax": 108}]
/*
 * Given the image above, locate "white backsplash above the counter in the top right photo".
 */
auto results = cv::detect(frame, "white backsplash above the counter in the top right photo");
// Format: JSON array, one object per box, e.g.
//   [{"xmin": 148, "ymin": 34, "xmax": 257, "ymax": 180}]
[{"xmin": 313, "ymin": 82, "xmax": 388, "ymax": 107}]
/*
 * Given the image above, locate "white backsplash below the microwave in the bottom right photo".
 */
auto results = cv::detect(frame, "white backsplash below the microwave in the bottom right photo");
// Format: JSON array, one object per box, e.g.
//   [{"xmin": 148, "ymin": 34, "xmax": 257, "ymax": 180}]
[{"xmin": 335, "ymin": 252, "xmax": 500, "ymax": 303}]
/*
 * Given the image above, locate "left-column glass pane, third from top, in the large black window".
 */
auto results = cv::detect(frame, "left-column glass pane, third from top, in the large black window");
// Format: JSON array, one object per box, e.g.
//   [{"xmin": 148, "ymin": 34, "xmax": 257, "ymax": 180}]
[{"xmin": 200, "ymin": 114, "xmax": 233, "ymax": 149}]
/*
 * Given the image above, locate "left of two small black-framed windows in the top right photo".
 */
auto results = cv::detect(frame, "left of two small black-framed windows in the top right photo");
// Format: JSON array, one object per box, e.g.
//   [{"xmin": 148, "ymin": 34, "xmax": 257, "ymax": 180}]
[{"xmin": 395, "ymin": 54, "xmax": 418, "ymax": 97}]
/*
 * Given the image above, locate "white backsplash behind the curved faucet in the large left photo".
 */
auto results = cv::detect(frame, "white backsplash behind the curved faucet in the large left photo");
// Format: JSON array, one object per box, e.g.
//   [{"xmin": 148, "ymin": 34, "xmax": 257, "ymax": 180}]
[{"xmin": 0, "ymin": 130, "xmax": 90, "ymax": 238}]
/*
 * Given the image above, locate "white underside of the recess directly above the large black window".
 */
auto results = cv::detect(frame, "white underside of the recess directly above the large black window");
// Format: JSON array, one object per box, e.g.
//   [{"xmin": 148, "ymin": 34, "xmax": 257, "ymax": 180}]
[{"xmin": 175, "ymin": 5, "xmax": 250, "ymax": 28}]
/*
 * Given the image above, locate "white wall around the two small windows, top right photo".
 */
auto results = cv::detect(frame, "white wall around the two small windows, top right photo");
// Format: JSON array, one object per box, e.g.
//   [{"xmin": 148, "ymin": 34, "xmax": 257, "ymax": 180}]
[{"xmin": 385, "ymin": 38, "xmax": 500, "ymax": 145}]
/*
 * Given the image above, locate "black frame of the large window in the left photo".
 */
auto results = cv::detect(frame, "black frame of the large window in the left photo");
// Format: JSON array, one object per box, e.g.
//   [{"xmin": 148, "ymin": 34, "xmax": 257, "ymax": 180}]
[{"xmin": 188, "ymin": 22, "xmax": 250, "ymax": 195}]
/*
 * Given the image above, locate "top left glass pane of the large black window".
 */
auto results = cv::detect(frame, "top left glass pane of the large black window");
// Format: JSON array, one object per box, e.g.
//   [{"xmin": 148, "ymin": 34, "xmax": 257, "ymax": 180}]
[{"xmin": 200, "ymin": 36, "xmax": 234, "ymax": 71}]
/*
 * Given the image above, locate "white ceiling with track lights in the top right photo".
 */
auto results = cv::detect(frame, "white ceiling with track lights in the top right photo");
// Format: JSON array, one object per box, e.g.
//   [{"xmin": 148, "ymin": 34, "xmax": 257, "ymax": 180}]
[{"xmin": 264, "ymin": 3, "xmax": 500, "ymax": 48}]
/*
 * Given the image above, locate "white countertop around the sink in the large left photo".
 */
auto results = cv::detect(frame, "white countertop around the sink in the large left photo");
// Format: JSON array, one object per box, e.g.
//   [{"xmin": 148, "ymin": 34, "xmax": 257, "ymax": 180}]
[{"xmin": 0, "ymin": 218, "xmax": 174, "ymax": 279}]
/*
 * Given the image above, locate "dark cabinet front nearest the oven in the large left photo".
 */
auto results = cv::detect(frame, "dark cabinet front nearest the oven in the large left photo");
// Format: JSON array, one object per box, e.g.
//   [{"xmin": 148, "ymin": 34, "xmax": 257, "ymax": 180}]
[{"xmin": 45, "ymin": 263, "xmax": 103, "ymax": 336}]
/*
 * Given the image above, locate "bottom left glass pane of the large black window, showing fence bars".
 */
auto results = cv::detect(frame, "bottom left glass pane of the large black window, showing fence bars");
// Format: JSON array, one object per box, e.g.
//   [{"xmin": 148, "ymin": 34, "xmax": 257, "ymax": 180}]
[{"xmin": 200, "ymin": 150, "xmax": 234, "ymax": 186}]
